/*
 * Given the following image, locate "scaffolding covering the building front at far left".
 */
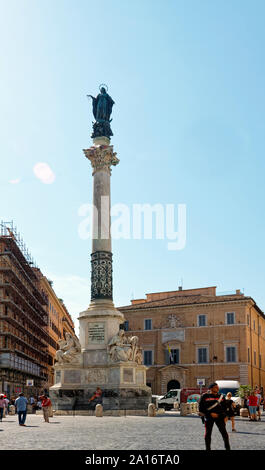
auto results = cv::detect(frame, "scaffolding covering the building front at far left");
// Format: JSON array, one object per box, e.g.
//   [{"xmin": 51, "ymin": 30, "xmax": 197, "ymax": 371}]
[{"xmin": 0, "ymin": 221, "xmax": 49, "ymax": 394}]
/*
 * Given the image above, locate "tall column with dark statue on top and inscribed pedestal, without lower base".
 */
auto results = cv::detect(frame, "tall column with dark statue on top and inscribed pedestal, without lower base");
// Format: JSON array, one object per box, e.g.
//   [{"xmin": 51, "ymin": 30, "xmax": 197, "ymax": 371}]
[{"xmin": 79, "ymin": 85, "xmax": 124, "ymax": 364}]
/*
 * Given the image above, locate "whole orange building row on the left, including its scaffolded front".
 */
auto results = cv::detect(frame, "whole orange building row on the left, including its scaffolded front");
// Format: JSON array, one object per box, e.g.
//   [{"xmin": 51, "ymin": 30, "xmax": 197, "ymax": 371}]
[{"xmin": 0, "ymin": 222, "xmax": 74, "ymax": 397}]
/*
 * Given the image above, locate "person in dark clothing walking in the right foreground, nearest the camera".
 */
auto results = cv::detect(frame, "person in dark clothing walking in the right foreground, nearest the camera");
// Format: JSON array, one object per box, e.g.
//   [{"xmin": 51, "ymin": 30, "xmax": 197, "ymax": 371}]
[{"xmin": 199, "ymin": 383, "xmax": 230, "ymax": 450}]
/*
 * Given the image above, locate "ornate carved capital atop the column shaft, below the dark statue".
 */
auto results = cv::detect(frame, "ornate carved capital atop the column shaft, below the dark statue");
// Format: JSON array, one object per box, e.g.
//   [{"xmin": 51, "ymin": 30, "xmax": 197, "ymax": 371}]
[{"xmin": 83, "ymin": 145, "xmax": 120, "ymax": 175}]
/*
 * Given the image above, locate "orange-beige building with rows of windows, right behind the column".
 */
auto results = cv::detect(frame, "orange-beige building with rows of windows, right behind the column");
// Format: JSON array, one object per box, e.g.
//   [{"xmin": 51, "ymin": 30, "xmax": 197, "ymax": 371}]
[{"xmin": 119, "ymin": 287, "xmax": 265, "ymax": 394}]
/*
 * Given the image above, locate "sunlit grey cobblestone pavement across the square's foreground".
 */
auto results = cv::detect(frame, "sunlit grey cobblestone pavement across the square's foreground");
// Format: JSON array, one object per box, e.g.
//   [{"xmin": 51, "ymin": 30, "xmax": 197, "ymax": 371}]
[{"xmin": 0, "ymin": 412, "xmax": 265, "ymax": 450}]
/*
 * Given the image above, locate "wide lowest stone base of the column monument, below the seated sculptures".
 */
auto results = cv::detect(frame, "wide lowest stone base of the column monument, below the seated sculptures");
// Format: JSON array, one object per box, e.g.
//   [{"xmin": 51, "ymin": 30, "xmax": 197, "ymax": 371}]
[{"xmin": 50, "ymin": 362, "xmax": 151, "ymax": 415}]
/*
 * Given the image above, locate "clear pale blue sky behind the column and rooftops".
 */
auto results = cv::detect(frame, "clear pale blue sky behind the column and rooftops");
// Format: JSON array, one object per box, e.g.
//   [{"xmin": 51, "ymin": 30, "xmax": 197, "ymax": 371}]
[{"xmin": 0, "ymin": 0, "xmax": 265, "ymax": 330}]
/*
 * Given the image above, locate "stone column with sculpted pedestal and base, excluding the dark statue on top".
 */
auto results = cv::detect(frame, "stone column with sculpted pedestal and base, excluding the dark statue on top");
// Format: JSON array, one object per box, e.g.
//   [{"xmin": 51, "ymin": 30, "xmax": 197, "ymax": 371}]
[{"xmin": 50, "ymin": 137, "xmax": 151, "ymax": 415}]
